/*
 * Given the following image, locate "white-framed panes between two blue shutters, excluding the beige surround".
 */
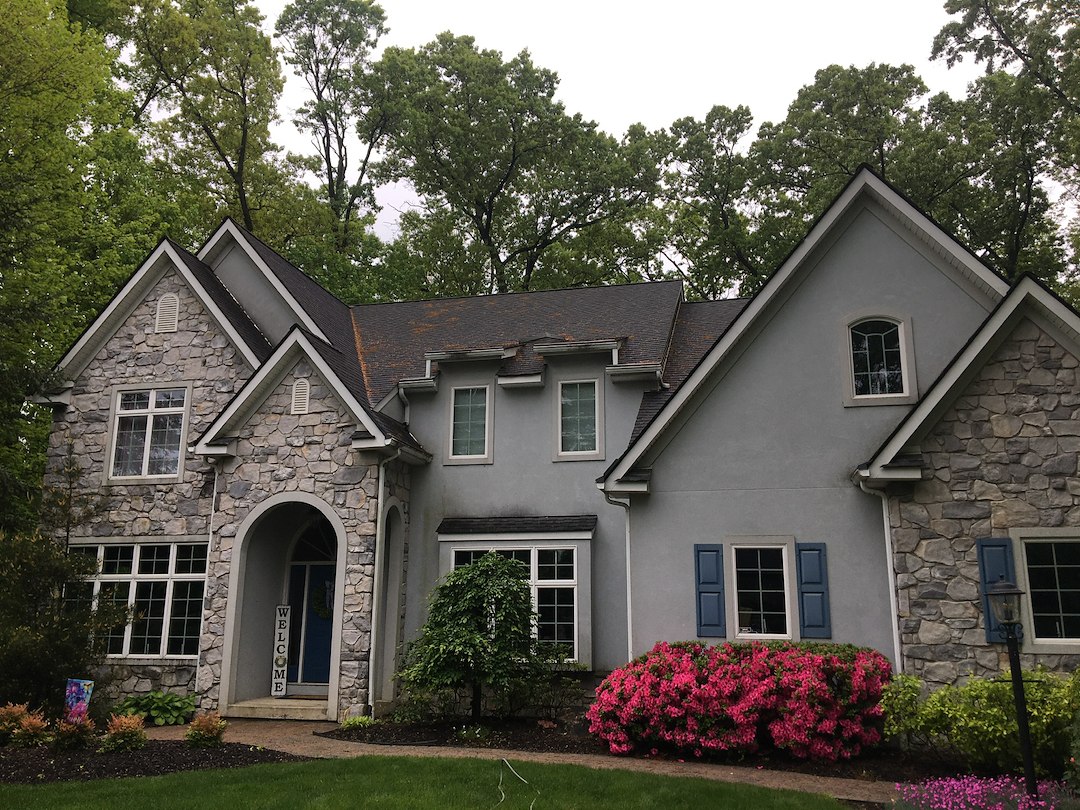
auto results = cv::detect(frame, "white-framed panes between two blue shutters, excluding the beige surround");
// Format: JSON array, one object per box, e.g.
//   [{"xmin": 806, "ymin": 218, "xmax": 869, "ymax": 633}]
[{"xmin": 734, "ymin": 546, "xmax": 788, "ymax": 636}]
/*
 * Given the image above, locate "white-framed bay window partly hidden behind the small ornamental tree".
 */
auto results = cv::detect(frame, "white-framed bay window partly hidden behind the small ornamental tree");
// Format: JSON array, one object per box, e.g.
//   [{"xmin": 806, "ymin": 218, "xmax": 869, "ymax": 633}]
[{"xmin": 440, "ymin": 532, "xmax": 592, "ymax": 666}]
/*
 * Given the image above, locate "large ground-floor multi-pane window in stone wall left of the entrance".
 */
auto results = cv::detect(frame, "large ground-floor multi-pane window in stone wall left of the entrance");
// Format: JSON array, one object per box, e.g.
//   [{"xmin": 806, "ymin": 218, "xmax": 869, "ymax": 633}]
[{"xmin": 72, "ymin": 543, "xmax": 206, "ymax": 656}]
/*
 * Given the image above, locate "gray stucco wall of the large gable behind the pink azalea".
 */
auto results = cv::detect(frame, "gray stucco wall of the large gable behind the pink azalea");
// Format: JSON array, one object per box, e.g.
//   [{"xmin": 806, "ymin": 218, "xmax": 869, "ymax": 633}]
[{"xmin": 632, "ymin": 207, "xmax": 989, "ymax": 658}]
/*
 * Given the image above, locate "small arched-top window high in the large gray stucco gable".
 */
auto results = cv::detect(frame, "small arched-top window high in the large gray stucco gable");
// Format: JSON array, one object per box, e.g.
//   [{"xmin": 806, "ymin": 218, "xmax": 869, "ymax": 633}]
[{"xmin": 847, "ymin": 316, "xmax": 916, "ymax": 405}]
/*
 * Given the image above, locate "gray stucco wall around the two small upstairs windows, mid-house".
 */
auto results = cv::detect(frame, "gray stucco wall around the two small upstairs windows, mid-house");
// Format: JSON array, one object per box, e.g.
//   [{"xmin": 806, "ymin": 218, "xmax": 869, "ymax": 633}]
[{"xmin": 406, "ymin": 352, "xmax": 643, "ymax": 670}]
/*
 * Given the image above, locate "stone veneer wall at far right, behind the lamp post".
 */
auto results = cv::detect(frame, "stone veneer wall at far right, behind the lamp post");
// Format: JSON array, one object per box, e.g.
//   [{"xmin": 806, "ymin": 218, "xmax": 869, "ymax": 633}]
[{"xmin": 890, "ymin": 320, "xmax": 1080, "ymax": 685}]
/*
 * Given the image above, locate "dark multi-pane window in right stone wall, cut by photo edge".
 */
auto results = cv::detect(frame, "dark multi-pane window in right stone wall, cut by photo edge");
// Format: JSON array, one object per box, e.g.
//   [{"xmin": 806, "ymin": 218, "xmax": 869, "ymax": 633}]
[{"xmin": 1024, "ymin": 541, "xmax": 1080, "ymax": 639}]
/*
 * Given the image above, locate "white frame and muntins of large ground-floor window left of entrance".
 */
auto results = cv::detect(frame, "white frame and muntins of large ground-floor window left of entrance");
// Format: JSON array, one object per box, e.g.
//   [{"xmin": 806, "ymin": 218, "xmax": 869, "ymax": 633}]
[{"xmin": 71, "ymin": 535, "xmax": 211, "ymax": 661}]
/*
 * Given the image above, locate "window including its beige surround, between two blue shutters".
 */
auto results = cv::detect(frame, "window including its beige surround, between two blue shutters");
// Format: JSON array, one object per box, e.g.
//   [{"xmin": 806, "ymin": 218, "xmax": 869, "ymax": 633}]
[{"xmin": 725, "ymin": 537, "xmax": 798, "ymax": 638}]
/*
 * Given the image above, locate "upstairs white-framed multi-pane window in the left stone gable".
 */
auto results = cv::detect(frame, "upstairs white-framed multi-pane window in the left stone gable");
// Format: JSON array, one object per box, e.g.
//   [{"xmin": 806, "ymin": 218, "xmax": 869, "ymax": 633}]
[{"xmin": 112, "ymin": 388, "xmax": 187, "ymax": 477}]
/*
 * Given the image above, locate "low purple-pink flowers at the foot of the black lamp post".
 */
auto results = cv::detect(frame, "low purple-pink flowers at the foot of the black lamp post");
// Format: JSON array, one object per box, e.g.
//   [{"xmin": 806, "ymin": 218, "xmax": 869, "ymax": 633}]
[{"xmin": 894, "ymin": 777, "xmax": 1072, "ymax": 810}]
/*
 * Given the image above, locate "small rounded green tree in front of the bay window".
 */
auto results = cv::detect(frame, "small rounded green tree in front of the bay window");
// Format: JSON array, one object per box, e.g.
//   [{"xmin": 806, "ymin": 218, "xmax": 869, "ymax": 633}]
[{"xmin": 399, "ymin": 552, "xmax": 537, "ymax": 719}]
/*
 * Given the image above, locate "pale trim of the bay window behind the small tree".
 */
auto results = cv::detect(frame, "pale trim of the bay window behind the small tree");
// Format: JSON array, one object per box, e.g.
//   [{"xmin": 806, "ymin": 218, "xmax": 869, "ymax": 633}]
[{"xmin": 437, "ymin": 531, "xmax": 593, "ymax": 670}]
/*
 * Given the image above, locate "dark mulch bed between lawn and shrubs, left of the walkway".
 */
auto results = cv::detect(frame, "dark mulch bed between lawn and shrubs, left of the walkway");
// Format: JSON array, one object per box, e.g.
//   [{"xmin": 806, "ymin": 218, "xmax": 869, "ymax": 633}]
[{"xmin": 0, "ymin": 740, "xmax": 307, "ymax": 784}]
